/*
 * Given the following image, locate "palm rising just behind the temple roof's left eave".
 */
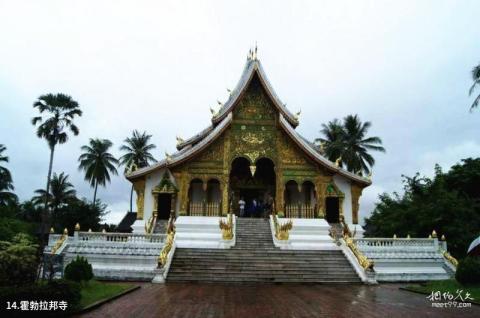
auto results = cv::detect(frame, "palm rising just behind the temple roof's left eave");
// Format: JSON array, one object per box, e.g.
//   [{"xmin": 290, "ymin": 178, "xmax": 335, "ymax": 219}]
[{"xmin": 119, "ymin": 130, "xmax": 157, "ymax": 212}]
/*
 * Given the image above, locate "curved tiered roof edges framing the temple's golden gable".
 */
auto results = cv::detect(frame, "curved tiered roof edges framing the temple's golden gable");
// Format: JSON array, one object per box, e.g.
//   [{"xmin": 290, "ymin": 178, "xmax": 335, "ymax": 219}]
[{"xmin": 126, "ymin": 57, "xmax": 371, "ymax": 185}]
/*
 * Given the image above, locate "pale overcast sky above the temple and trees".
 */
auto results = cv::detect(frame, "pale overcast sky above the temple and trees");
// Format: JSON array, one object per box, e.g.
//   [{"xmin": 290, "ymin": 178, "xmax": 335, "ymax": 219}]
[{"xmin": 0, "ymin": 0, "xmax": 480, "ymax": 222}]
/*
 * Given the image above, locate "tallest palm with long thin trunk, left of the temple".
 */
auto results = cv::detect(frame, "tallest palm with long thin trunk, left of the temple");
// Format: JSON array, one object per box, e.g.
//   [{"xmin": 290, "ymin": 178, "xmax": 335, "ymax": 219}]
[{"xmin": 32, "ymin": 93, "xmax": 82, "ymax": 226}]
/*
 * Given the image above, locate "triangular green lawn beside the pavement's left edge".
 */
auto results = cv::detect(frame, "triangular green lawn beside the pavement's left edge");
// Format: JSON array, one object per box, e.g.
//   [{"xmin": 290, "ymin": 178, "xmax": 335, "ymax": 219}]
[{"xmin": 80, "ymin": 280, "xmax": 135, "ymax": 308}]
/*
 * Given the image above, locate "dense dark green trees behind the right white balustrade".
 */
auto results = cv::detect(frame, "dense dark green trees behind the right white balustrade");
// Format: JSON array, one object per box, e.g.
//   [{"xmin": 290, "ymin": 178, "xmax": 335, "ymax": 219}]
[{"xmin": 365, "ymin": 158, "xmax": 480, "ymax": 258}]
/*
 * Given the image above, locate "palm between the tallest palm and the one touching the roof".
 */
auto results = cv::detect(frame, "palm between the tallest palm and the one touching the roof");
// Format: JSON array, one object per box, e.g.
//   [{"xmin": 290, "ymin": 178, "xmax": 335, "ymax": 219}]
[{"xmin": 78, "ymin": 138, "xmax": 118, "ymax": 205}]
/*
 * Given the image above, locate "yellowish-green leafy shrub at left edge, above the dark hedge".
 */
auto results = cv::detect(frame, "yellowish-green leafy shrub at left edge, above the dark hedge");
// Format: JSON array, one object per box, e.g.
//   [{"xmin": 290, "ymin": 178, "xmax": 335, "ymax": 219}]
[{"xmin": 0, "ymin": 233, "xmax": 38, "ymax": 286}]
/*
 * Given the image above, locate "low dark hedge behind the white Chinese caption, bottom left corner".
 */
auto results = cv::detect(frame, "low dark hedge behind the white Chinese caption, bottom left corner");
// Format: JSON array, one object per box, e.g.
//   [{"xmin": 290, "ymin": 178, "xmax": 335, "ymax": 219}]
[{"xmin": 0, "ymin": 280, "xmax": 81, "ymax": 316}]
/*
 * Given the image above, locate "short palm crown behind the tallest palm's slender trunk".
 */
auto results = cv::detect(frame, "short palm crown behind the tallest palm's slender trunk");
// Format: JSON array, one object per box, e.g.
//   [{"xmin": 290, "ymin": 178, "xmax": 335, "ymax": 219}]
[{"xmin": 32, "ymin": 172, "xmax": 77, "ymax": 215}]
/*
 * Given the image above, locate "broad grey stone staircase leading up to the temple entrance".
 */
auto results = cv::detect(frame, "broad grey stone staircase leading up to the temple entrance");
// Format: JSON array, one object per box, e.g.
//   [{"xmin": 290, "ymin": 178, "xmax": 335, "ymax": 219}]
[{"xmin": 167, "ymin": 218, "xmax": 361, "ymax": 283}]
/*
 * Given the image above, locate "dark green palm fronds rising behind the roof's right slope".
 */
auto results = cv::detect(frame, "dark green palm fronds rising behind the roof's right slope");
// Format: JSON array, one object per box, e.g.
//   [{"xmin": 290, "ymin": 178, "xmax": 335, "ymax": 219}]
[{"xmin": 316, "ymin": 115, "xmax": 385, "ymax": 174}]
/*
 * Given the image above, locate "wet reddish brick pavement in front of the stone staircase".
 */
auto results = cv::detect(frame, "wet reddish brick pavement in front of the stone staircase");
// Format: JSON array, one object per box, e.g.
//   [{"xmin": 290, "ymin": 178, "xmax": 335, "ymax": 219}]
[{"xmin": 83, "ymin": 283, "xmax": 480, "ymax": 318}]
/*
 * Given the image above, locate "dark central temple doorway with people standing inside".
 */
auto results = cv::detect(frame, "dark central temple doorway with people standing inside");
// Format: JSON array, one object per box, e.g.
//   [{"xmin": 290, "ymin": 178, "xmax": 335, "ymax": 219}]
[{"xmin": 230, "ymin": 157, "xmax": 275, "ymax": 217}]
